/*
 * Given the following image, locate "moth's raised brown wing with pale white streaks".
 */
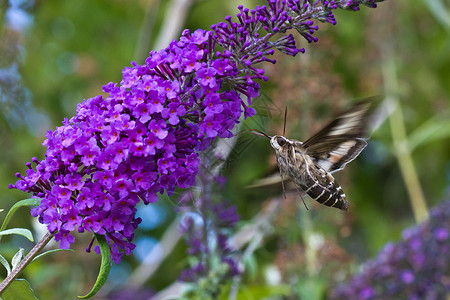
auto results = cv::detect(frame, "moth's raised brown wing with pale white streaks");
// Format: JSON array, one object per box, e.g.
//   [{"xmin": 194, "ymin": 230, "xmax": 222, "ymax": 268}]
[{"xmin": 303, "ymin": 100, "xmax": 374, "ymax": 173}]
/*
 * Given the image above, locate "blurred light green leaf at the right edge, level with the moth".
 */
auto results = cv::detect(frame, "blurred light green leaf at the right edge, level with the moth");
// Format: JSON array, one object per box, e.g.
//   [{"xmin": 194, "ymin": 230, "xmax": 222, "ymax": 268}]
[{"xmin": 408, "ymin": 114, "xmax": 450, "ymax": 152}]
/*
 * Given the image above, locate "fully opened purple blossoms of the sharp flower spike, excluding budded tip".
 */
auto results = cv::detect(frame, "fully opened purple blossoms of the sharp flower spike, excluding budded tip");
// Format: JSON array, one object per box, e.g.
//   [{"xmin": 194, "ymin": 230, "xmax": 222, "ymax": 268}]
[{"xmin": 15, "ymin": 30, "xmax": 246, "ymax": 261}]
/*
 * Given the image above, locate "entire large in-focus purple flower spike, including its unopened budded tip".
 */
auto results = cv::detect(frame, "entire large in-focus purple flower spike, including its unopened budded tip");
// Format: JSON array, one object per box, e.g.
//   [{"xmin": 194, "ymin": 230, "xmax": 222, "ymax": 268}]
[{"xmin": 10, "ymin": 0, "xmax": 380, "ymax": 262}]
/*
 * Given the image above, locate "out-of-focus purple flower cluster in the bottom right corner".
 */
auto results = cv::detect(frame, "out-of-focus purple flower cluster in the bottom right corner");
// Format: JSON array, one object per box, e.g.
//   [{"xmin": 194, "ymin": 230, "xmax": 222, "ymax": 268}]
[{"xmin": 331, "ymin": 200, "xmax": 450, "ymax": 300}]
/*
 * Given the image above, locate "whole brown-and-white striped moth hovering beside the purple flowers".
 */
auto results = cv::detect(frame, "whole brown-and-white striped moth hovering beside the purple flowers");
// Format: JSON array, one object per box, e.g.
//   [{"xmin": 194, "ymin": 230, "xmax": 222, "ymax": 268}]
[{"xmin": 252, "ymin": 100, "xmax": 374, "ymax": 210}]
